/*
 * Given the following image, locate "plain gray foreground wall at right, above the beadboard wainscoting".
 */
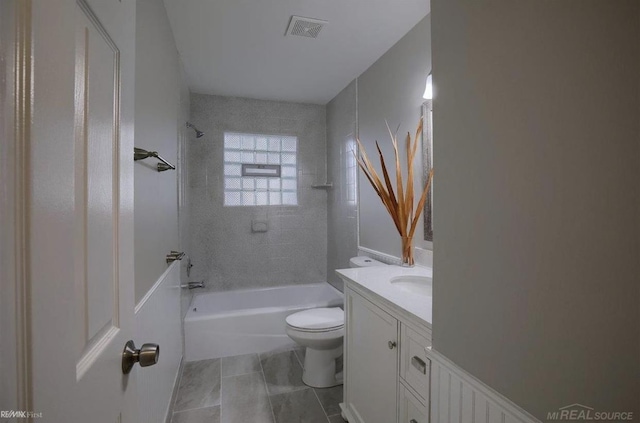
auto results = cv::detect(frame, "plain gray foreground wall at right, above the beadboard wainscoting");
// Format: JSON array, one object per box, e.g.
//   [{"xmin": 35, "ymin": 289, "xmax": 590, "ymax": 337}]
[{"xmin": 431, "ymin": 0, "xmax": 640, "ymax": 421}]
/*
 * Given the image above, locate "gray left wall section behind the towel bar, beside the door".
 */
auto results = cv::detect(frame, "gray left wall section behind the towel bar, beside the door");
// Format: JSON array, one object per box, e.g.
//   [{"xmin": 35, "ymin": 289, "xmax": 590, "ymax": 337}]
[{"xmin": 134, "ymin": 0, "xmax": 185, "ymax": 302}]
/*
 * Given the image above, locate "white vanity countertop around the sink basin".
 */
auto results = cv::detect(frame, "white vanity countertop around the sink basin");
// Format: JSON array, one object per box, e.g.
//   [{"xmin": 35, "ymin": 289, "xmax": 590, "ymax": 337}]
[{"xmin": 336, "ymin": 265, "xmax": 433, "ymax": 327}]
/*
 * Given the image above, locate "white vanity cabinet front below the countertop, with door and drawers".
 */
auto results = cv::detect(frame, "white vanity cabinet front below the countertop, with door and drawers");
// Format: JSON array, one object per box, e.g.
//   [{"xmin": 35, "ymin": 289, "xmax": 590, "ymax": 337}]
[{"xmin": 341, "ymin": 281, "xmax": 431, "ymax": 423}]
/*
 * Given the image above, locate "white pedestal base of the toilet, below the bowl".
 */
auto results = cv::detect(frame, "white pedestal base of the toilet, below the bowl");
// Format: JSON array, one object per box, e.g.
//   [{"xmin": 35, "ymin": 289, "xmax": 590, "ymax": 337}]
[{"xmin": 302, "ymin": 345, "xmax": 342, "ymax": 388}]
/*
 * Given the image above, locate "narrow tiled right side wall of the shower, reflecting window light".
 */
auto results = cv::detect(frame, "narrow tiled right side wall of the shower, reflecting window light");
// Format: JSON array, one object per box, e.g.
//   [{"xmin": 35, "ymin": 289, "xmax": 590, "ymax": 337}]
[{"xmin": 327, "ymin": 80, "xmax": 359, "ymax": 291}]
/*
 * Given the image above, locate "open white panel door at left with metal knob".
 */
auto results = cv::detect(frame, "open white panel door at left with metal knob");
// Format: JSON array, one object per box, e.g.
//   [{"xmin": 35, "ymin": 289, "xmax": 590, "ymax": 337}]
[{"xmin": 26, "ymin": 0, "xmax": 136, "ymax": 423}]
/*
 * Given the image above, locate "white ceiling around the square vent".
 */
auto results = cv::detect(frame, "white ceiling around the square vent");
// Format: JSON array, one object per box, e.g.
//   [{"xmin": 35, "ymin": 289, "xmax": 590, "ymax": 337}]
[{"xmin": 164, "ymin": 0, "xmax": 429, "ymax": 104}]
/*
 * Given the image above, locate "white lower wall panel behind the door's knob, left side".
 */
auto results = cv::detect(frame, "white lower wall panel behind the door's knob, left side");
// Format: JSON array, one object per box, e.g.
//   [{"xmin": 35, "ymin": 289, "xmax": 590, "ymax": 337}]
[{"xmin": 134, "ymin": 261, "xmax": 182, "ymax": 423}]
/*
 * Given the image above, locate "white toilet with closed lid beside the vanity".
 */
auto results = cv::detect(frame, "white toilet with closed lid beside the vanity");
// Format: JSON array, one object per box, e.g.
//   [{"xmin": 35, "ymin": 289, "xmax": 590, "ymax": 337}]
[{"xmin": 286, "ymin": 256, "xmax": 386, "ymax": 388}]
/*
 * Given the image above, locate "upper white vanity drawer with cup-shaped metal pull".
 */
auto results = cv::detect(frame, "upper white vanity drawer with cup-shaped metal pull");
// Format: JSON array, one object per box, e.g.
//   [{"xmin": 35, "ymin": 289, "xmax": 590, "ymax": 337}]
[{"xmin": 400, "ymin": 324, "xmax": 431, "ymax": 402}]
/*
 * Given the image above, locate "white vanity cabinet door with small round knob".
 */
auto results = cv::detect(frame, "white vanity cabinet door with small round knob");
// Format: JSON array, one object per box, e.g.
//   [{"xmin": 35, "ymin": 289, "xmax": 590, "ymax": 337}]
[{"xmin": 345, "ymin": 290, "xmax": 398, "ymax": 423}]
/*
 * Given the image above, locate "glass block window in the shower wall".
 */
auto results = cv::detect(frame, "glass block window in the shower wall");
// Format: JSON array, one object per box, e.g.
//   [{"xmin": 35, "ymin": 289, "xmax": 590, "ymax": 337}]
[{"xmin": 224, "ymin": 132, "xmax": 298, "ymax": 206}]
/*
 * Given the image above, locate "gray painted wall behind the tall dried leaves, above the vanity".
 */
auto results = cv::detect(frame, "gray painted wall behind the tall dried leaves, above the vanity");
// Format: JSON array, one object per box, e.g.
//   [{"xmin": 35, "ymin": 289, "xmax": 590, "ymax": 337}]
[{"xmin": 358, "ymin": 15, "xmax": 431, "ymax": 257}]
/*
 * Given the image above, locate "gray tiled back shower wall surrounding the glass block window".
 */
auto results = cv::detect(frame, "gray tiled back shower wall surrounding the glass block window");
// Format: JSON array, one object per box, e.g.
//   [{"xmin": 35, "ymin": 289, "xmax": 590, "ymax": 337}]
[{"xmin": 188, "ymin": 94, "xmax": 327, "ymax": 291}]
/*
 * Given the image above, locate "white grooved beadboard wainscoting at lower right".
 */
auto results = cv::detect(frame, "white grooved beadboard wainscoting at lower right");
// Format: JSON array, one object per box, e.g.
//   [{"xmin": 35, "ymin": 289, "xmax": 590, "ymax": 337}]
[{"xmin": 426, "ymin": 348, "xmax": 540, "ymax": 423}]
